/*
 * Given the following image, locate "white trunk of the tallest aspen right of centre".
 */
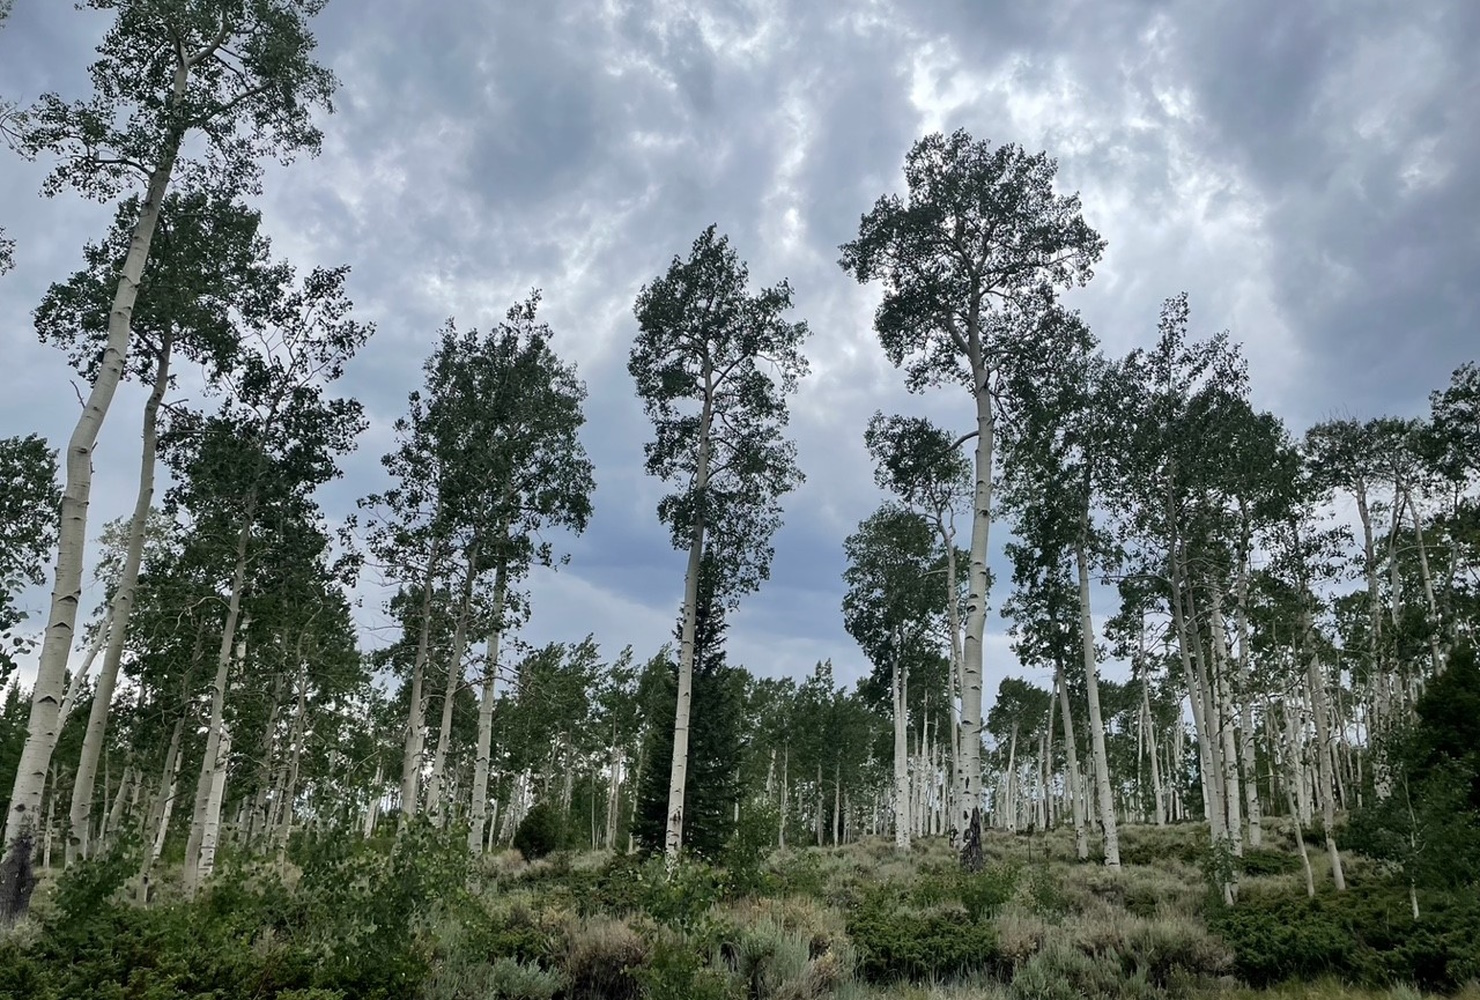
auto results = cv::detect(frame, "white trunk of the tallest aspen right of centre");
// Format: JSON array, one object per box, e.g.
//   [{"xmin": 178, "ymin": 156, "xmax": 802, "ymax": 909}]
[{"xmin": 956, "ymin": 365, "xmax": 996, "ymax": 830}]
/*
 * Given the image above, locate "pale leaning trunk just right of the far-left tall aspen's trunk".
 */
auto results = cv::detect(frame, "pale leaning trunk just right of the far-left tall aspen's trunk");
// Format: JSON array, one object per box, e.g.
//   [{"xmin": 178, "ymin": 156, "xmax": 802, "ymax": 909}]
[{"xmin": 67, "ymin": 333, "xmax": 173, "ymax": 864}]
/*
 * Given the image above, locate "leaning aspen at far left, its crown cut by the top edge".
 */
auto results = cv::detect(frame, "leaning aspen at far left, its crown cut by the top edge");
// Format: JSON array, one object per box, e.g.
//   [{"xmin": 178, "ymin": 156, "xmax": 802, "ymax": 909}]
[{"xmin": 4, "ymin": 0, "xmax": 334, "ymax": 911}]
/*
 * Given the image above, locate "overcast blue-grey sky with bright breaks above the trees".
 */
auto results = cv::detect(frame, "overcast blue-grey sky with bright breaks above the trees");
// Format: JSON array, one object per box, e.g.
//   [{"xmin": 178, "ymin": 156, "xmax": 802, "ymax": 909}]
[{"xmin": 0, "ymin": 0, "xmax": 1480, "ymax": 704}]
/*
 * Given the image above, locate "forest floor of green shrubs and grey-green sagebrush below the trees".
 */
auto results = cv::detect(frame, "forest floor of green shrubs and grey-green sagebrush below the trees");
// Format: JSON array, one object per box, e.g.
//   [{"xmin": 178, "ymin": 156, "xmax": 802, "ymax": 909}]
[{"xmin": 0, "ymin": 824, "xmax": 1480, "ymax": 1000}]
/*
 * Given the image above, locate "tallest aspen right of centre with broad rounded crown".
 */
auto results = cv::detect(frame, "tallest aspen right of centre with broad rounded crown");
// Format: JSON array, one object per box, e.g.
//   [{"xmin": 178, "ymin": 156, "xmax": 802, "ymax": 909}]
[{"xmin": 839, "ymin": 130, "xmax": 1104, "ymax": 830}]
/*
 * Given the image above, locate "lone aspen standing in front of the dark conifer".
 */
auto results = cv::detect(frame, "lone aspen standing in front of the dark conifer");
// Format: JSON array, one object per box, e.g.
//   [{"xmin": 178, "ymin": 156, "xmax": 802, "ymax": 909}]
[{"xmin": 628, "ymin": 226, "xmax": 808, "ymax": 864}]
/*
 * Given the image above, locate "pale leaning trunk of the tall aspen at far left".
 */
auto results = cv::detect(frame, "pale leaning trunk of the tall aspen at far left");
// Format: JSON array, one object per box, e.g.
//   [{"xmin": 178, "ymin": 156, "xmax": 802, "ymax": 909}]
[{"xmin": 0, "ymin": 127, "xmax": 189, "ymax": 881}]
